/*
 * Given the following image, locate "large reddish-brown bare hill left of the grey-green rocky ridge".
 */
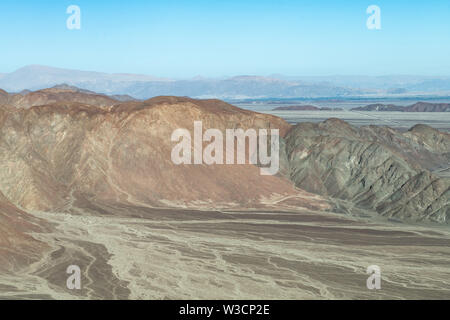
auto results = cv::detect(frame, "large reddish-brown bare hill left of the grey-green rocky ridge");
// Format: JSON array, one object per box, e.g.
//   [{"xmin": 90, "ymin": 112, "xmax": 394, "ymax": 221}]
[{"xmin": 0, "ymin": 97, "xmax": 327, "ymax": 210}]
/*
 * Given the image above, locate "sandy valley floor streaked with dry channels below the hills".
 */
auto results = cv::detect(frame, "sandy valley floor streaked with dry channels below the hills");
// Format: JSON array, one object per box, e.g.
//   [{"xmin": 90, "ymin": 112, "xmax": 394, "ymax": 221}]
[{"xmin": 0, "ymin": 205, "xmax": 450, "ymax": 299}]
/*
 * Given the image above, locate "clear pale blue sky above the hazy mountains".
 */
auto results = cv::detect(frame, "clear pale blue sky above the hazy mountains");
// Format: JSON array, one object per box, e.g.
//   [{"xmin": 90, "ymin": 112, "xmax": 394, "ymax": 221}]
[{"xmin": 0, "ymin": 0, "xmax": 450, "ymax": 78}]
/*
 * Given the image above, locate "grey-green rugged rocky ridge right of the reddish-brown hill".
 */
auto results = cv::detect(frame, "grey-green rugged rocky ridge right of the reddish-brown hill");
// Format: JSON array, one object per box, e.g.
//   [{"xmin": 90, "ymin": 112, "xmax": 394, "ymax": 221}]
[{"xmin": 286, "ymin": 119, "xmax": 450, "ymax": 223}]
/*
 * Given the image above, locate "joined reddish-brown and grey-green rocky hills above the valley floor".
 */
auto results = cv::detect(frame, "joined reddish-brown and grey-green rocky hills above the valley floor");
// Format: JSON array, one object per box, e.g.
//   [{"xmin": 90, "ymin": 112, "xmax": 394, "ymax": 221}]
[{"xmin": 0, "ymin": 93, "xmax": 450, "ymax": 222}]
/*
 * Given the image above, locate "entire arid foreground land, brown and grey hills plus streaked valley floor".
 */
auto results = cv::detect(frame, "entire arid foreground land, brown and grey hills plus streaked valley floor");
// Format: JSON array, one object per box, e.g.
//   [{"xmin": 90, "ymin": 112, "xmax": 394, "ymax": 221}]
[{"xmin": 0, "ymin": 87, "xmax": 450, "ymax": 299}]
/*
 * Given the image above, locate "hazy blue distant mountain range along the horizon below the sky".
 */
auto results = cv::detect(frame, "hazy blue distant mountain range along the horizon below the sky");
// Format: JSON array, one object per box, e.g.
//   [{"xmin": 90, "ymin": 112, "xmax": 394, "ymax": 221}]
[{"xmin": 0, "ymin": 65, "xmax": 450, "ymax": 100}]
